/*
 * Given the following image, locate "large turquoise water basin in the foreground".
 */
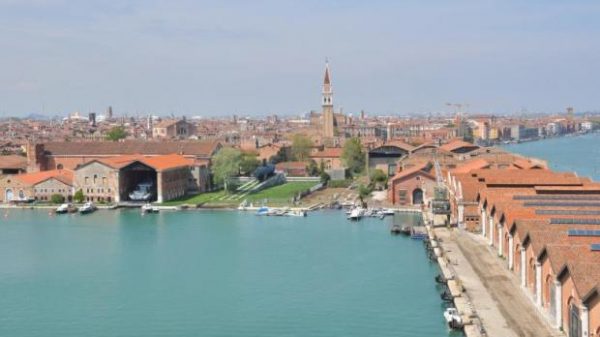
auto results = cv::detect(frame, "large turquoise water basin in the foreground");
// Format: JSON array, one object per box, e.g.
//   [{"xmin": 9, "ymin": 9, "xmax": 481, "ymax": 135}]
[{"xmin": 0, "ymin": 210, "xmax": 458, "ymax": 337}]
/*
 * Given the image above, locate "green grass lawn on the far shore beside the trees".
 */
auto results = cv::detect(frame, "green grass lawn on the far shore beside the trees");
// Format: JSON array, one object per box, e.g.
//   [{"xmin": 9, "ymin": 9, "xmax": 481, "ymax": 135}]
[{"xmin": 163, "ymin": 181, "xmax": 317, "ymax": 206}]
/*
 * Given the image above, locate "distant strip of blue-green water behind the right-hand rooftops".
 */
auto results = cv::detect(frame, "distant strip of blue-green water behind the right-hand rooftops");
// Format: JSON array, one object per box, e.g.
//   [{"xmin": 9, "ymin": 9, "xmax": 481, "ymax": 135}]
[{"xmin": 504, "ymin": 133, "xmax": 600, "ymax": 181}]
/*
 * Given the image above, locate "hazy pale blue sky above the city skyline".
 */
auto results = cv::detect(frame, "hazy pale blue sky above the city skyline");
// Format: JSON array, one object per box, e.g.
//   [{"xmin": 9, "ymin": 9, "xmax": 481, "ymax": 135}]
[{"xmin": 0, "ymin": 0, "xmax": 600, "ymax": 116}]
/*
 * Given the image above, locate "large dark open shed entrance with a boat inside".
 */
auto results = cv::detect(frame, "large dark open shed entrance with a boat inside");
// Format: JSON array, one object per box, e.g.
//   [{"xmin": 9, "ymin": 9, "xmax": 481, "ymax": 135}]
[{"xmin": 119, "ymin": 161, "xmax": 158, "ymax": 202}]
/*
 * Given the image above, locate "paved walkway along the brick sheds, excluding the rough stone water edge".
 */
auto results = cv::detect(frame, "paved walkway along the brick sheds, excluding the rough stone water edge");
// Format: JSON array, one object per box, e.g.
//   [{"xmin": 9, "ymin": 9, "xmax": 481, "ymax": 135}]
[{"xmin": 438, "ymin": 230, "xmax": 563, "ymax": 337}]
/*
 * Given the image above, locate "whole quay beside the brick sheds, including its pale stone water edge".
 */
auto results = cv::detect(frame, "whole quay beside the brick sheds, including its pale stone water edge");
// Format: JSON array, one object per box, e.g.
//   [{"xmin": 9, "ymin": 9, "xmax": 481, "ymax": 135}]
[{"xmin": 428, "ymin": 223, "xmax": 564, "ymax": 337}]
